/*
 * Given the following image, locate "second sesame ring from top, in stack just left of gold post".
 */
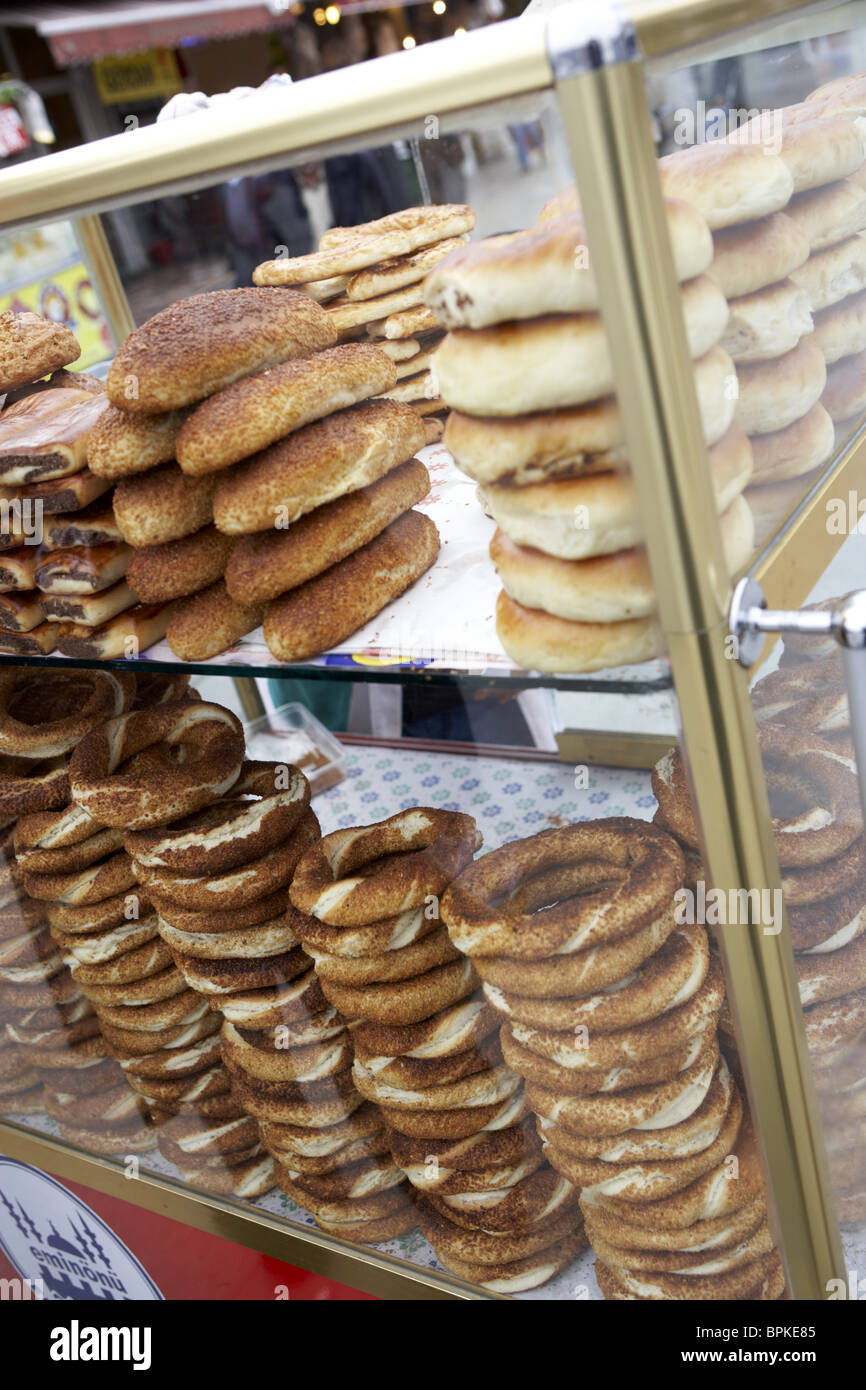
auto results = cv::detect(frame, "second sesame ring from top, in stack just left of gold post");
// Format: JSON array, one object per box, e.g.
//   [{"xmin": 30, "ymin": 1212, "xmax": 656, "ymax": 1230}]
[{"xmin": 473, "ymin": 908, "xmax": 676, "ymax": 999}]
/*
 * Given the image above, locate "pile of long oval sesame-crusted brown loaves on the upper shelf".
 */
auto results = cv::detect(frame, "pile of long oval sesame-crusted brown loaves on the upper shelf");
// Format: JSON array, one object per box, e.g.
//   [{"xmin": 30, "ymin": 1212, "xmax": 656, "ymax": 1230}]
[{"xmin": 93, "ymin": 286, "xmax": 438, "ymax": 662}]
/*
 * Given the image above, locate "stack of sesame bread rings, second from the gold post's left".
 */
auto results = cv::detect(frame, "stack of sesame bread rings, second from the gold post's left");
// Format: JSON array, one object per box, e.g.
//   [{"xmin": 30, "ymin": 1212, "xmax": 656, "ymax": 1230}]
[{"xmin": 286, "ymin": 806, "xmax": 584, "ymax": 1293}]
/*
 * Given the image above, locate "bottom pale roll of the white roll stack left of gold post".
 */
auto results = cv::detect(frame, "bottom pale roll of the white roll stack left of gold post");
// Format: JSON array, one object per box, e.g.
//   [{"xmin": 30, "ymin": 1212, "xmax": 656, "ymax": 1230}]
[{"xmin": 496, "ymin": 589, "xmax": 664, "ymax": 676}]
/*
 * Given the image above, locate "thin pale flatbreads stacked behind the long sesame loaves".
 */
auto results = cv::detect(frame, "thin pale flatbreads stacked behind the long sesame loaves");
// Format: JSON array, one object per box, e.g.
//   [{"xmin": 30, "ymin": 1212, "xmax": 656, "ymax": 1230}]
[{"xmin": 253, "ymin": 203, "xmax": 475, "ymax": 428}]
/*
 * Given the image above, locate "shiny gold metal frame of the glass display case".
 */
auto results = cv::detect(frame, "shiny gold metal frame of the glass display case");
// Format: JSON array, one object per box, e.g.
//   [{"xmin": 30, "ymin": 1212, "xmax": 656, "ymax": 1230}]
[{"xmin": 0, "ymin": 0, "xmax": 865, "ymax": 1298}]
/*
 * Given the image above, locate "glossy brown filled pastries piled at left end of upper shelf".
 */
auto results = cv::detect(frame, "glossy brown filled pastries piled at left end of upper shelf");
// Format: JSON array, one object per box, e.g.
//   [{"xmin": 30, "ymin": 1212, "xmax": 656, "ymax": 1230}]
[{"xmin": 0, "ymin": 313, "xmax": 118, "ymax": 656}]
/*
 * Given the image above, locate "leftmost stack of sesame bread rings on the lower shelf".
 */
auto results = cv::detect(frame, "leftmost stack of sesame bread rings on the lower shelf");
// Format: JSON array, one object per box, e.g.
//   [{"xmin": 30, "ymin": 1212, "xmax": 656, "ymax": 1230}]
[{"xmin": 0, "ymin": 667, "xmax": 162, "ymax": 1154}]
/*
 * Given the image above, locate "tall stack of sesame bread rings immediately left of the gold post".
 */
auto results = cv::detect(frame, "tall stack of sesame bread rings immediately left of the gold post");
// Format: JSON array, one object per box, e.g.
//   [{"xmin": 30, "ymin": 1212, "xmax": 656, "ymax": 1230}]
[{"xmin": 442, "ymin": 817, "xmax": 784, "ymax": 1298}]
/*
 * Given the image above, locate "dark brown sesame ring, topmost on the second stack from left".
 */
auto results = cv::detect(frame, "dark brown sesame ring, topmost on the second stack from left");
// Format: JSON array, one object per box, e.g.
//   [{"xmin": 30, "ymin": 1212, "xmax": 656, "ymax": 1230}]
[{"xmin": 70, "ymin": 701, "xmax": 243, "ymax": 830}]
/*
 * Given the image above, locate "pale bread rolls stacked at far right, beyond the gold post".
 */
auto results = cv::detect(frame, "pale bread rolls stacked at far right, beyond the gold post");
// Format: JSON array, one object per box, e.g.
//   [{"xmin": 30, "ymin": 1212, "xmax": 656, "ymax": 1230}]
[{"xmin": 706, "ymin": 103, "xmax": 866, "ymax": 539}]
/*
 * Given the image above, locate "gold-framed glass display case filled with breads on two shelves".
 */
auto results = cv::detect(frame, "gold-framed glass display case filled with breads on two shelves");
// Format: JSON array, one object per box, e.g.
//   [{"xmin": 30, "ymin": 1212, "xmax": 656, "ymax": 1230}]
[{"xmin": 0, "ymin": 0, "xmax": 866, "ymax": 1301}]
